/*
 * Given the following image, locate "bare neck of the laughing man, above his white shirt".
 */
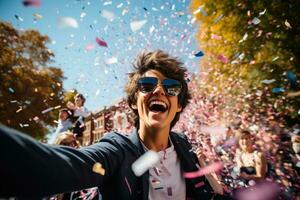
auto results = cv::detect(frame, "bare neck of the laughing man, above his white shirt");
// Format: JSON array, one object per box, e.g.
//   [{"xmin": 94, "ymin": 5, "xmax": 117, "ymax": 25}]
[{"xmin": 138, "ymin": 126, "xmax": 170, "ymax": 152}]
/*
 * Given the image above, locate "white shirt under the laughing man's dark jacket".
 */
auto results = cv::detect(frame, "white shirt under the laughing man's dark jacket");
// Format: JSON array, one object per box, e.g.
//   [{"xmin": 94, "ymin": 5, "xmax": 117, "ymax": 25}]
[{"xmin": 144, "ymin": 140, "xmax": 186, "ymax": 200}]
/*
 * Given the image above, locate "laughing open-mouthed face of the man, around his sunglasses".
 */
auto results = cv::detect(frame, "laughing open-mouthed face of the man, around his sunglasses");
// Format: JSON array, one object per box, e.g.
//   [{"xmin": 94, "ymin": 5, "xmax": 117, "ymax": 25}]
[{"xmin": 133, "ymin": 70, "xmax": 181, "ymax": 129}]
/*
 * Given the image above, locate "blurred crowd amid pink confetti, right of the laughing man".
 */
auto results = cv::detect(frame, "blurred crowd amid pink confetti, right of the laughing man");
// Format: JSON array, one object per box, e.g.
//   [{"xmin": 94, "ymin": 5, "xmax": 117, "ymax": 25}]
[{"xmin": 175, "ymin": 77, "xmax": 300, "ymax": 199}]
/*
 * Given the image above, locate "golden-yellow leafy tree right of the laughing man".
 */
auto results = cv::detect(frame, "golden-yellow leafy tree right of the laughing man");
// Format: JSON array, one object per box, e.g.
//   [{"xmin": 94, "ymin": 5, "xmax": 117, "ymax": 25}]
[{"xmin": 190, "ymin": 0, "xmax": 300, "ymax": 125}]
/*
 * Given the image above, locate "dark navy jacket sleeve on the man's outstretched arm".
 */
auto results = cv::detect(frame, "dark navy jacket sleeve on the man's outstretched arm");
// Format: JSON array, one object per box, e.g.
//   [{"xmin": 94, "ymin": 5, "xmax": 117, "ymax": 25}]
[{"xmin": 0, "ymin": 126, "xmax": 124, "ymax": 198}]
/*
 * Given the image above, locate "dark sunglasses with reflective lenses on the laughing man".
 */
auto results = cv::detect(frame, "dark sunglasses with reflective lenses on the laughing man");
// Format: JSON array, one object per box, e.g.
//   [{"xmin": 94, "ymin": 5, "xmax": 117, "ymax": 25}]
[{"xmin": 137, "ymin": 77, "xmax": 181, "ymax": 96}]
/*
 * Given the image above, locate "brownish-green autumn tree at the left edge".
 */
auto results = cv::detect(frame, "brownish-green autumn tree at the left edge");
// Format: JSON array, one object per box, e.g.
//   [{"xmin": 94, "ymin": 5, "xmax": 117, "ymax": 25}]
[{"xmin": 0, "ymin": 22, "xmax": 64, "ymax": 139}]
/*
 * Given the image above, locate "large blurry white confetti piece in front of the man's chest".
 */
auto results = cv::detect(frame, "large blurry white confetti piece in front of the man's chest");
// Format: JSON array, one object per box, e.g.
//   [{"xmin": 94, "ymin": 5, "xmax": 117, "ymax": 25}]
[{"xmin": 131, "ymin": 150, "xmax": 159, "ymax": 176}]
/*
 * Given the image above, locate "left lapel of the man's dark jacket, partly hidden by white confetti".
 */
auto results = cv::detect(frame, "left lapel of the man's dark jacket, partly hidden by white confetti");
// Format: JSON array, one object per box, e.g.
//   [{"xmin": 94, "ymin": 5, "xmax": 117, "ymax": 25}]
[{"xmin": 130, "ymin": 130, "xmax": 149, "ymax": 200}]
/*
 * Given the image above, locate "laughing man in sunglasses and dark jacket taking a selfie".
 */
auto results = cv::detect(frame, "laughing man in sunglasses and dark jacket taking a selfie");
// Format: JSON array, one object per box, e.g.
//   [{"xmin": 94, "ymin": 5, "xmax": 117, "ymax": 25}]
[{"xmin": 0, "ymin": 50, "xmax": 230, "ymax": 200}]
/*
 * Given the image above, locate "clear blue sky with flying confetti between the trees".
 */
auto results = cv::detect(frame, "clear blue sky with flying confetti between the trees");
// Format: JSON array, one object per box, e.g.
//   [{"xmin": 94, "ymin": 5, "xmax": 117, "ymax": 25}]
[{"xmin": 0, "ymin": 0, "xmax": 199, "ymax": 111}]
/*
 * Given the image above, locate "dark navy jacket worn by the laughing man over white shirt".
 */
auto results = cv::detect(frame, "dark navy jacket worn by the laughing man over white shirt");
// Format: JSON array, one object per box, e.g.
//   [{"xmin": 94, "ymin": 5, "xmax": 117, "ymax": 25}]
[{"xmin": 0, "ymin": 126, "xmax": 230, "ymax": 200}]
